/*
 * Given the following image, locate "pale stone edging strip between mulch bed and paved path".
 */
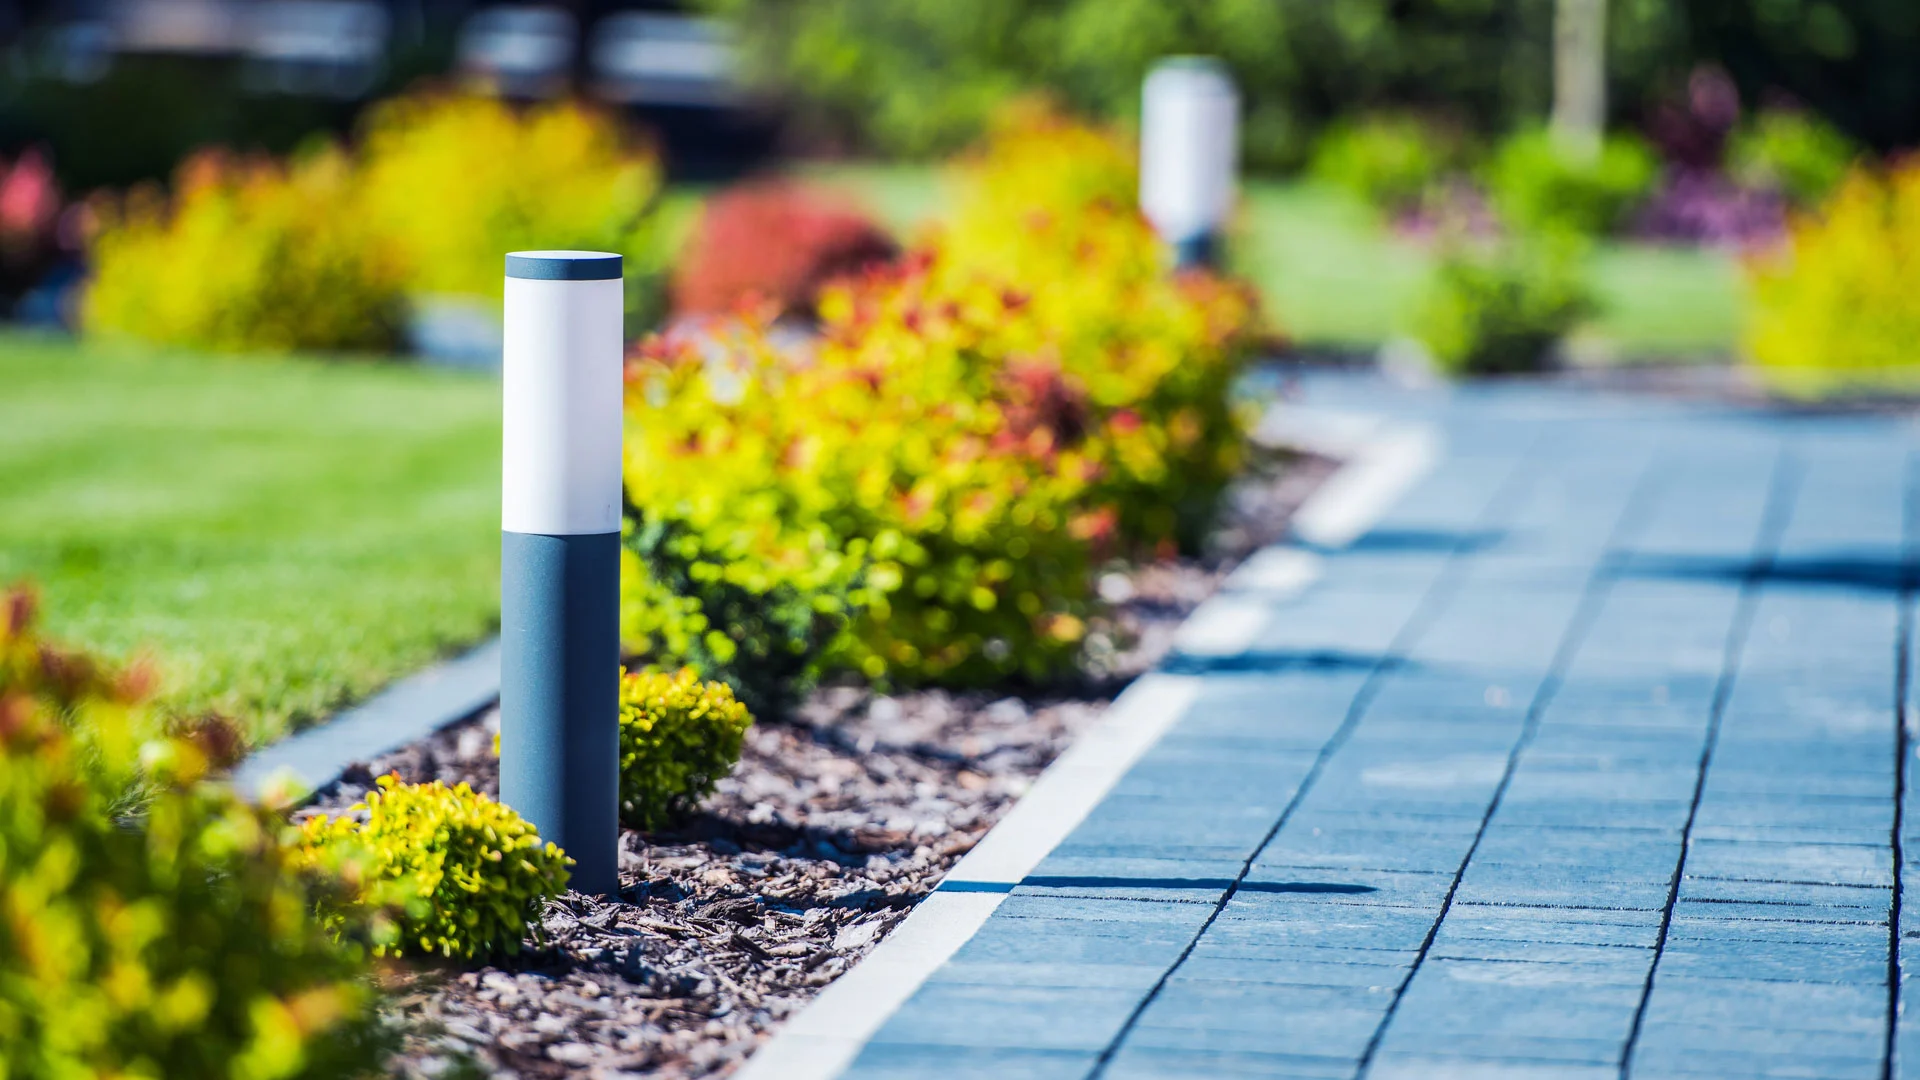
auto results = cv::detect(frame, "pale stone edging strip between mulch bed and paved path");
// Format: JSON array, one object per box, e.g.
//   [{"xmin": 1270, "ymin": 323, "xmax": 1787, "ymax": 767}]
[{"xmin": 733, "ymin": 405, "xmax": 1442, "ymax": 1080}]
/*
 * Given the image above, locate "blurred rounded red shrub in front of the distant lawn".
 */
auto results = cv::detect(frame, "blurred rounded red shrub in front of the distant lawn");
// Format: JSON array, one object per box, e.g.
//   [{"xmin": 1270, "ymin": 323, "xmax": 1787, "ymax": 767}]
[{"xmin": 674, "ymin": 181, "xmax": 899, "ymax": 317}]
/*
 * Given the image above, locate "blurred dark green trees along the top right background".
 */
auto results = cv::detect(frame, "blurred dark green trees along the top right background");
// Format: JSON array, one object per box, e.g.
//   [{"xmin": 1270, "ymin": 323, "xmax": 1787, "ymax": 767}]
[{"xmin": 697, "ymin": 0, "xmax": 1920, "ymax": 167}]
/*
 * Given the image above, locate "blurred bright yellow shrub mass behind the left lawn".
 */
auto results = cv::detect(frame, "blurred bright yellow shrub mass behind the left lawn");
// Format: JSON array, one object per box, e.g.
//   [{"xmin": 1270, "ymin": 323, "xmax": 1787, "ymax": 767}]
[{"xmin": 83, "ymin": 92, "xmax": 664, "ymax": 352}]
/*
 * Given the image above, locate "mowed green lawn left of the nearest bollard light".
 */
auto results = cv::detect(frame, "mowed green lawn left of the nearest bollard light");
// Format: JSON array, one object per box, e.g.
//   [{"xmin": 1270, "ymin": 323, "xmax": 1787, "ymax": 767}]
[{"xmin": 0, "ymin": 334, "xmax": 499, "ymax": 742}]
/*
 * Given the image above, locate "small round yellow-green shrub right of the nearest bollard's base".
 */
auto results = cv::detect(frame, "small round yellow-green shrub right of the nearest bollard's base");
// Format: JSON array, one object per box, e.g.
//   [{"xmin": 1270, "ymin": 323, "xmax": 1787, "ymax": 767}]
[{"xmin": 620, "ymin": 667, "xmax": 753, "ymax": 830}]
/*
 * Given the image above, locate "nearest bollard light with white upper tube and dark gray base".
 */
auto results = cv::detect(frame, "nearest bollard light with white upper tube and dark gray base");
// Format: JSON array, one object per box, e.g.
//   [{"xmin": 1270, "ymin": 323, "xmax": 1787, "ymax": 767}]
[{"xmin": 499, "ymin": 252, "xmax": 622, "ymax": 896}]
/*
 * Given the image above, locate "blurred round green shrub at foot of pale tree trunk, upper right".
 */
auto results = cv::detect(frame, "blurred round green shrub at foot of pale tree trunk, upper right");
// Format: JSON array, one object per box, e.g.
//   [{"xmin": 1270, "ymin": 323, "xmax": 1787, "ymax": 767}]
[{"xmin": 1486, "ymin": 127, "xmax": 1659, "ymax": 236}]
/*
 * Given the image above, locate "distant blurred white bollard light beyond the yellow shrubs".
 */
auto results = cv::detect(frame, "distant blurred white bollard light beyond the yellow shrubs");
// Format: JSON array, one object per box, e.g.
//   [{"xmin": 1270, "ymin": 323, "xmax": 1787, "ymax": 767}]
[{"xmin": 1140, "ymin": 56, "xmax": 1240, "ymax": 265}]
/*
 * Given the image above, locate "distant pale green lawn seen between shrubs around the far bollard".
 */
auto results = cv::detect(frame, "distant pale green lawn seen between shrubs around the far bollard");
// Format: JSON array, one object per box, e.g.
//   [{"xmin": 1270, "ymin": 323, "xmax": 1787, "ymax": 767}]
[{"xmin": 801, "ymin": 165, "xmax": 1741, "ymax": 359}]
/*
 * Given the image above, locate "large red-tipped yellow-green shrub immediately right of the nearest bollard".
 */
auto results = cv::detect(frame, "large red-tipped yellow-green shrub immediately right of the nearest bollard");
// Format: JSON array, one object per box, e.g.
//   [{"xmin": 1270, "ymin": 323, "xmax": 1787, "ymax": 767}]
[{"xmin": 628, "ymin": 292, "xmax": 1112, "ymax": 682}]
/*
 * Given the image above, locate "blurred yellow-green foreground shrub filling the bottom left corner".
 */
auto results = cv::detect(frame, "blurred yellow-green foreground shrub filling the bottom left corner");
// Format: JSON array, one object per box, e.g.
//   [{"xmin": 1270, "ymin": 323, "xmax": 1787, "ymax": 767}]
[{"xmin": 0, "ymin": 594, "xmax": 380, "ymax": 1080}]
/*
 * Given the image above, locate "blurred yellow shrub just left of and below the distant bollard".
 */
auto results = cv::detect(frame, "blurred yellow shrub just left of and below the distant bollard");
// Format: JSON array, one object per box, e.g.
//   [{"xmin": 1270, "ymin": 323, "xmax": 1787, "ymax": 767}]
[{"xmin": 931, "ymin": 108, "xmax": 1261, "ymax": 550}]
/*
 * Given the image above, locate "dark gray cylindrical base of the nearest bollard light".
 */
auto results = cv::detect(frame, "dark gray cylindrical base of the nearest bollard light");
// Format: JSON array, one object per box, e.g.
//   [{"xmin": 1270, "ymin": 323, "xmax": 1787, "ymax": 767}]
[{"xmin": 499, "ymin": 532, "xmax": 620, "ymax": 896}]
